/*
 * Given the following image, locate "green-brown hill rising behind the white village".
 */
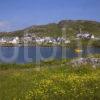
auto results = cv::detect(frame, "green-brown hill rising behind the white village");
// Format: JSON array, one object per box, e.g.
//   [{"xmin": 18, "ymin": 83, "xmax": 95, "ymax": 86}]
[{"xmin": 0, "ymin": 20, "xmax": 100, "ymax": 37}]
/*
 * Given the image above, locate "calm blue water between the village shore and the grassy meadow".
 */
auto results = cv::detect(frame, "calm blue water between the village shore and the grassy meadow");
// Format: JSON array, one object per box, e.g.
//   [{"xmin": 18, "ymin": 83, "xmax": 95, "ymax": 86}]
[{"xmin": 0, "ymin": 47, "xmax": 100, "ymax": 63}]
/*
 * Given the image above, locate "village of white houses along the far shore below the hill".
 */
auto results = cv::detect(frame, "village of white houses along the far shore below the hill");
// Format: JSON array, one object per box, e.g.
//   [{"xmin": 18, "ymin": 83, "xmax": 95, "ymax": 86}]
[{"xmin": 0, "ymin": 32, "xmax": 95, "ymax": 45}]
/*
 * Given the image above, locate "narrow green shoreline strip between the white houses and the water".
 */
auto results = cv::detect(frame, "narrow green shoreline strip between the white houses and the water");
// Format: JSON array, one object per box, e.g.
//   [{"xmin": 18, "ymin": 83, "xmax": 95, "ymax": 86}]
[{"xmin": 0, "ymin": 40, "xmax": 100, "ymax": 48}]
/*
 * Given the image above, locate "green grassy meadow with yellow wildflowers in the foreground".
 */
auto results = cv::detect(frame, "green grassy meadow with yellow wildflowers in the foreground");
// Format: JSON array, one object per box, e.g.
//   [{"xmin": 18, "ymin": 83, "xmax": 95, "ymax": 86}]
[{"xmin": 0, "ymin": 61, "xmax": 100, "ymax": 100}]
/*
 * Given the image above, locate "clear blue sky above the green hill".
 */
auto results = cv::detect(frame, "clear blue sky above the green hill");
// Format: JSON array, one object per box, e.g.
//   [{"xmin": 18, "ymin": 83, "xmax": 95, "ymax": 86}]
[{"xmin": 0, "ymin": 0, "xmax": 100, "ymax": 31}]
